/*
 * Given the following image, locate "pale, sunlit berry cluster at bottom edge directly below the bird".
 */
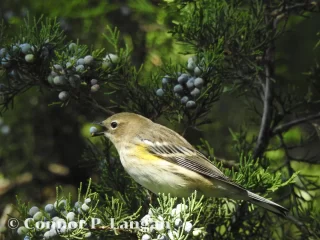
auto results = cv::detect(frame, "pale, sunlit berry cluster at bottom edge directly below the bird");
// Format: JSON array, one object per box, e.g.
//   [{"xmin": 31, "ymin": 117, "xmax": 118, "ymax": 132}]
[{"xmin": 141, "ymin": 204, "xmax": 202, "ymax": 240}]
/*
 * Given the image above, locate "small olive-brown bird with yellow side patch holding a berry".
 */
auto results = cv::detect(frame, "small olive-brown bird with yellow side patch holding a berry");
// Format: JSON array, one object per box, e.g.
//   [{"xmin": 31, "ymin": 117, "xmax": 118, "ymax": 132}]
[{"xmin": 92, "ymin": 112, "xmax": 288, "ymax": 216}]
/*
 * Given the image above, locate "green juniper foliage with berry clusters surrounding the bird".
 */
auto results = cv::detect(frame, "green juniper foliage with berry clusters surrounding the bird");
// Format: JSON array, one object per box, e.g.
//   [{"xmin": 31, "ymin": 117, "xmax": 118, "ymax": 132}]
[{"xmin": 0, "ymin": 0, "xmax": 320, "ymax": 240}]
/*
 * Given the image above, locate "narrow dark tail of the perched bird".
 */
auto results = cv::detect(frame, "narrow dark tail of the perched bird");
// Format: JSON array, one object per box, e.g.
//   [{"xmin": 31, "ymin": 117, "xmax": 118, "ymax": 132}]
[{"xmin": 248, "ymin": 191, "xmax": 289, "ymax": 217}]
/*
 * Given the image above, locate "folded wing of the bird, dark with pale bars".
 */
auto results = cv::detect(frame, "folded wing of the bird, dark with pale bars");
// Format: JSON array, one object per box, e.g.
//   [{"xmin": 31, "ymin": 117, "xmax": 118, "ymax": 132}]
[{"xmin": 144, "ymin": 140, "xmax": 243, "ymax": 189}]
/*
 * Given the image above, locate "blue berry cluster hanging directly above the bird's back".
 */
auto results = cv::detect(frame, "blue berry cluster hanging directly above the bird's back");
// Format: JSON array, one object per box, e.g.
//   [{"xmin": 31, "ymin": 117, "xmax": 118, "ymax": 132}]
[{"xmin": 156, "ymin": 57, "xmax": 205, "ymax": 109}]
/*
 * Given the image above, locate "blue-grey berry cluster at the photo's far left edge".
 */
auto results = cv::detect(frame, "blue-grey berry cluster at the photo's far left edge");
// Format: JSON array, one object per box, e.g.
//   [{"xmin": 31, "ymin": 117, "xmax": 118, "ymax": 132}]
[{"xmin": 0, "ymin": 43, "xmax": 36, "ymax": 68}]
